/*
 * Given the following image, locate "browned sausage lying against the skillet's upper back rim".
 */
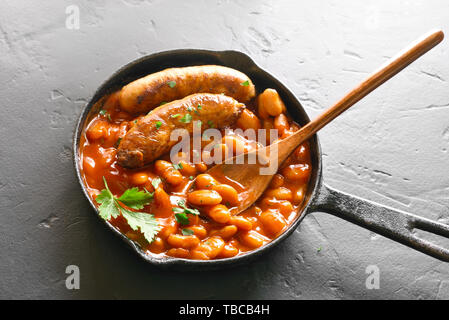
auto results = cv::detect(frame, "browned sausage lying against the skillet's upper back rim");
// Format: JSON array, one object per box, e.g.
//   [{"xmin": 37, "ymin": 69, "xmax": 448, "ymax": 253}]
[{"xmin": 119, "ymin": 65, "xmax": 256, "ymax": 114}]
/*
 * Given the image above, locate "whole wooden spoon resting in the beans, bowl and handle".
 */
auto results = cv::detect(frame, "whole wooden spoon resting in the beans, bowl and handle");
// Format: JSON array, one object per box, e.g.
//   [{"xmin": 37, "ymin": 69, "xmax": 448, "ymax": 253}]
[{"xmin": 207, "ymin": 30, "xmax": 444, "ymax": 215}]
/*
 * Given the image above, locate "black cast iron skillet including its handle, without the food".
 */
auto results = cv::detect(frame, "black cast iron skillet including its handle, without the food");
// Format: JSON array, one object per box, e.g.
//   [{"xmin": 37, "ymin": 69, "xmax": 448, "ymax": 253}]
[{"xmin": 73, "ymin": 49, "xmax": 449, "ymax": 270}]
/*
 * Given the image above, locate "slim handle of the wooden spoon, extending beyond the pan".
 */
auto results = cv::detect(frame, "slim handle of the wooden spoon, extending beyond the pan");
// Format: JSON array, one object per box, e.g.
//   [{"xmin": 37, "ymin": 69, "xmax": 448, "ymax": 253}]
[{"xmin": 289, "ymin": 30, "xmax": 444, "ymax": 144}]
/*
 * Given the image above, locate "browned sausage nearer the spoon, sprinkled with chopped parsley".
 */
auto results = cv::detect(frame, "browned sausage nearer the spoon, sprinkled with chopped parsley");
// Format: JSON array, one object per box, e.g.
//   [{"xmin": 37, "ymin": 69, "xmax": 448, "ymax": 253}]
[{"xmin": 117, "ymin": 93, "xmax": 245, "ymax": 168}]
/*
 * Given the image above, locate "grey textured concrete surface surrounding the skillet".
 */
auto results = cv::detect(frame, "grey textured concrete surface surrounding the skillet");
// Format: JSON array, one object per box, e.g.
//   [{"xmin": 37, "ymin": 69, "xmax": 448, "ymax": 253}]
[{"xmin": 0, "ymin": 0, "xmax": 449, "ymax": 299}]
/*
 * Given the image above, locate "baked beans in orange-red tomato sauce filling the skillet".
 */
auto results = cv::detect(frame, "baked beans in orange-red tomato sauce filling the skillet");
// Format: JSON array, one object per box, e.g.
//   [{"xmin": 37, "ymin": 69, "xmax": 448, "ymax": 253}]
[{"xmin": 80, "ymin": 89, "xmax": 312, "ymax": 260}]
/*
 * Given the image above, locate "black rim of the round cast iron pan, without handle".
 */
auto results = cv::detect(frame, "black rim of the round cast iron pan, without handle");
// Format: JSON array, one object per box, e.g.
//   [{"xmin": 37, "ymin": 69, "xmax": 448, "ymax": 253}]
[{"xmin": 72, "ymin": 49, "xmax": 322, "ymax": 270}]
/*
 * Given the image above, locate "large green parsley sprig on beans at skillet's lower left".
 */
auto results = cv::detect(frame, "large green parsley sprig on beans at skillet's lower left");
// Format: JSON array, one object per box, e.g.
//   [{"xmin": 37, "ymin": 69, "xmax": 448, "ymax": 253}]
[{"xmin": 95, "ymin": 177, "xmax": 161, "ymax": 243}]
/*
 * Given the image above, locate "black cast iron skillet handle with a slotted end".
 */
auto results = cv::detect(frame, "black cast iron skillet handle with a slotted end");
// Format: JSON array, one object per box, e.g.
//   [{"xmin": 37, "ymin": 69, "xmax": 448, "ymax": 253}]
[{"xmin": 310, "ymin": 184, "xmax": 449, "ymax": 262}]
